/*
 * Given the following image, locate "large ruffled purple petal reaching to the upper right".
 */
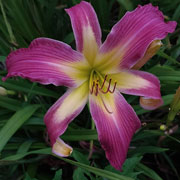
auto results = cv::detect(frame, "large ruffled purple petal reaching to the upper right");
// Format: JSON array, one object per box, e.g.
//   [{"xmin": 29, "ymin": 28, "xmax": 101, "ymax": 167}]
[{"xmin": 97, "ymin": 4, "xmax": 177, "ymax": 68}]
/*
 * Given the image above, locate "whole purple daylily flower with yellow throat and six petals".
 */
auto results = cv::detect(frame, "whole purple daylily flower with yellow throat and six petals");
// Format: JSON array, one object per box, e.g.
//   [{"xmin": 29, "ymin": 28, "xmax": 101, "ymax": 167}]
[{"xmin": 4, "ymin": 1, "xmax": 176, "ymax": 169}]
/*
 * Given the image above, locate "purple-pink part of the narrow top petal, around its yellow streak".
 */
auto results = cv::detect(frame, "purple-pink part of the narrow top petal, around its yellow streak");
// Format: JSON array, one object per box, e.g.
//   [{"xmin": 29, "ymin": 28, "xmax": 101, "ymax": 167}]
[{"xmin": 66, "ymin": 1, "xmax": 101, "ymax": 52}]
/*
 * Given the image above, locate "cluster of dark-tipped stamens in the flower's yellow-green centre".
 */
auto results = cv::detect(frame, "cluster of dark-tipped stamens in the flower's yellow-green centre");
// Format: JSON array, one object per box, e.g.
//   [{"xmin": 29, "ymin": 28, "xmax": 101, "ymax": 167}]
[{"xmin": 89, "ymin": 69, "xmax": 117, "ymax": 96}]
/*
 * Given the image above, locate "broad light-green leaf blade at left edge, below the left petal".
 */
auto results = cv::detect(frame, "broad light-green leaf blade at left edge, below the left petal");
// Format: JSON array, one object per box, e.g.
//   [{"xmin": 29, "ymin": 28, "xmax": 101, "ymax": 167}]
[{"xmin": 0, "ymin": 105, "xmax": 40, "ymax": 151}]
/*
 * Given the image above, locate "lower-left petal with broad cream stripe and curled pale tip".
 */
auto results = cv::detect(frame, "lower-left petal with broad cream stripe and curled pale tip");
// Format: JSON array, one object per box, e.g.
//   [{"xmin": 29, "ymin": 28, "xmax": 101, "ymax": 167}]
[{"xmin": 44, "ymin": 82, "xmax": 88, "ymax": 156}]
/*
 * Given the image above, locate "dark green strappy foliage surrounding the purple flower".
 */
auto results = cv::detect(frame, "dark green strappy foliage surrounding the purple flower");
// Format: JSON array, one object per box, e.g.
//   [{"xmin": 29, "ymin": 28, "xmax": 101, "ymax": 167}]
[{"xmin": 0, "ymin": 0, "xmax": 180, "ymax": 180}]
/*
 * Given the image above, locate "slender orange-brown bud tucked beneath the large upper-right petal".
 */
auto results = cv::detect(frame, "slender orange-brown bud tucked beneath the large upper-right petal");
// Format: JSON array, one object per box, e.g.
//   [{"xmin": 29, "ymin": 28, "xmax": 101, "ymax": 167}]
[{"xmin": 132, "ymin": 40, "xmax": 162, "ymax": 69}]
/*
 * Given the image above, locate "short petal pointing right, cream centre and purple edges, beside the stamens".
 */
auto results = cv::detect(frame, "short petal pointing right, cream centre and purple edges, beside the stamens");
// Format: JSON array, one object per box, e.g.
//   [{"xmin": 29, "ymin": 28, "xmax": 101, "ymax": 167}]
[{"xmin": 109, "ymin": 70, "xmax": 161, "ymax": 99}]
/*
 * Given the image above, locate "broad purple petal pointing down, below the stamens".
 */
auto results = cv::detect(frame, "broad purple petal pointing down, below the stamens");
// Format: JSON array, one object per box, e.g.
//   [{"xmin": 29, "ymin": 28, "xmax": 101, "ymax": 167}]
[{"xmin": 90, "ymin": 91, "xmax": 140, "ymax": 170}]
